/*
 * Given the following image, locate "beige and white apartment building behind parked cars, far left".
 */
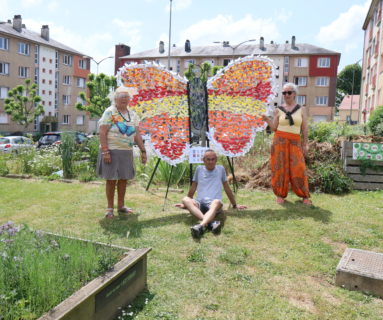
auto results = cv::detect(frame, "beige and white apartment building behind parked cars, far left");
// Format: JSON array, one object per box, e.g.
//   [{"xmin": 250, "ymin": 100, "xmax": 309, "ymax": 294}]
[{"xmin": 0, "ymin": 15, "xmax": 90, "ymax": 135}]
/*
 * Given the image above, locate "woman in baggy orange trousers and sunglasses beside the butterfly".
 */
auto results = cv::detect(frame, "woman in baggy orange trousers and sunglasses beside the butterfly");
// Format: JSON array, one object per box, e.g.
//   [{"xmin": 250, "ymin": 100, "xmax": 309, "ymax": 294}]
[{"xmin": 263, "ymin": 83, "xmax": 312, "ymax": 205}]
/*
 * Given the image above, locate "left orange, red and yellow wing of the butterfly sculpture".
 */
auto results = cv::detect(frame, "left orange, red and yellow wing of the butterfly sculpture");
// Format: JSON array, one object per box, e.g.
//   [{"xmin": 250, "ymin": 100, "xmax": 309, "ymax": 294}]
[{"xmin": 117, "ymin": 63, "xmax": 189, "ymax": 165}]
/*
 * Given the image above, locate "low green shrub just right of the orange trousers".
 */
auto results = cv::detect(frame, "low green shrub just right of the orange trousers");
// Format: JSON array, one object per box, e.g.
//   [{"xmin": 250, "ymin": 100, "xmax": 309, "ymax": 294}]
[{"xmin": 310, "ymin": 163, "xmax": 353, "ymax": 194}]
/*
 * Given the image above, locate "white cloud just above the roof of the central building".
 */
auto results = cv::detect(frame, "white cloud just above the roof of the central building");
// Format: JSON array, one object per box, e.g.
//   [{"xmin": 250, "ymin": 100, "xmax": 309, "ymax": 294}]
[{"xmin": 178, "ymin": 14, "xmax": 280, "ymax": 45}]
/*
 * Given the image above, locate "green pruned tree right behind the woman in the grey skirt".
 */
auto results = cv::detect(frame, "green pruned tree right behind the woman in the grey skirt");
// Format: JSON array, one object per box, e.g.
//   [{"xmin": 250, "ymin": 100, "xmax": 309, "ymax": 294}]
[{"xmin": 76, "ymin": 73, "xmax": 117, "ymax": 117}]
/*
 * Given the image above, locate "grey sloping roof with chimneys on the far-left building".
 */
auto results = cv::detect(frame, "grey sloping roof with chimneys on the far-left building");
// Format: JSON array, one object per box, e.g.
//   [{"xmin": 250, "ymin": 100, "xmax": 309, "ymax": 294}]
[{"xmin": 0, "ymin": 22, "xmax": 85, "ymax": 56}]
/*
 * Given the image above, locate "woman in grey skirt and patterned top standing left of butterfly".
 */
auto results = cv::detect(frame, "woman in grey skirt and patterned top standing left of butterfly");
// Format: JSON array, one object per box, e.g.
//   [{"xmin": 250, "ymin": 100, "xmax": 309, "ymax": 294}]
[{"xmin": 97, "ymin": 86, "xmax": 147, "ymax": 218}]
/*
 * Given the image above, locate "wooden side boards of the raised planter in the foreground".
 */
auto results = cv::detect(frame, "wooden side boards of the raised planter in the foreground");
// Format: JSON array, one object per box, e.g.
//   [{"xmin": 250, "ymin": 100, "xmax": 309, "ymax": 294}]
[{"xmin": 38, "ymin": 234, "xmax": 151, "ymax": 320}]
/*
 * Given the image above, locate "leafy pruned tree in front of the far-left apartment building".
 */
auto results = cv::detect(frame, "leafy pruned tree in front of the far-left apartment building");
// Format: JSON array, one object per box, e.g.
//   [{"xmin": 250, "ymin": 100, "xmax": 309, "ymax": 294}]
[{"xmin": 4, "ymin": 79, "xmax": 44, "ymax": 128}]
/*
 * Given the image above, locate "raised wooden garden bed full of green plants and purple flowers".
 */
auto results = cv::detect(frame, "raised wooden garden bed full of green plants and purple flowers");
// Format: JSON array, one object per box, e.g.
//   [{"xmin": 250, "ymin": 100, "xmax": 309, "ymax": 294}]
[{"xmin": 0, "ymin": 222, "xmax": 150, "ymax": 320}]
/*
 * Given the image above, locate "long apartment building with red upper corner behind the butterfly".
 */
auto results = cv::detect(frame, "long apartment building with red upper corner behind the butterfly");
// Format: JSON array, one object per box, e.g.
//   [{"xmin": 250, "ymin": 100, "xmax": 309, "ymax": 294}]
[{"xmin": 115, "ymin": 36, "xmax": 340, "ymax": 122}]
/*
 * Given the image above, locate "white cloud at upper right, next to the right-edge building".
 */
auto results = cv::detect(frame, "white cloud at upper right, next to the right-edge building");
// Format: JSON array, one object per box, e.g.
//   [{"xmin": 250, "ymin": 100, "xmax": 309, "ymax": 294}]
[{"xmin": 316, "ymin": 0, "xmax": 370, "ymax": 50}]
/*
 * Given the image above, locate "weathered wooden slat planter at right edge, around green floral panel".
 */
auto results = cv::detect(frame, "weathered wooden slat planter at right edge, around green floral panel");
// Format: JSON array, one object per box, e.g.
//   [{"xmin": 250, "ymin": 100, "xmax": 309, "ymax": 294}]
[{"xmin": 341, "ymin": 141, "xmax": 383, "ymax": 190}]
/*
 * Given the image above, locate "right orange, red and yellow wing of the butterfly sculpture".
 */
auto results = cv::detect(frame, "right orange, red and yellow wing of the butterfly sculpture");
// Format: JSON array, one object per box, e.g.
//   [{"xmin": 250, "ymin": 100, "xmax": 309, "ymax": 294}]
[{"xmin": 207, "ymin": 56, "xmax": 276, "ymax": 157}]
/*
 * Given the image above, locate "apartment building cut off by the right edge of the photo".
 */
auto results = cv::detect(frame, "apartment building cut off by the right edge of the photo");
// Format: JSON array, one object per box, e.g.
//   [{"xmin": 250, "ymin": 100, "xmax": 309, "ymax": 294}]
[{"xmin": 359, "ymin": 0, "xmax": 383, "ymax": 123}]
